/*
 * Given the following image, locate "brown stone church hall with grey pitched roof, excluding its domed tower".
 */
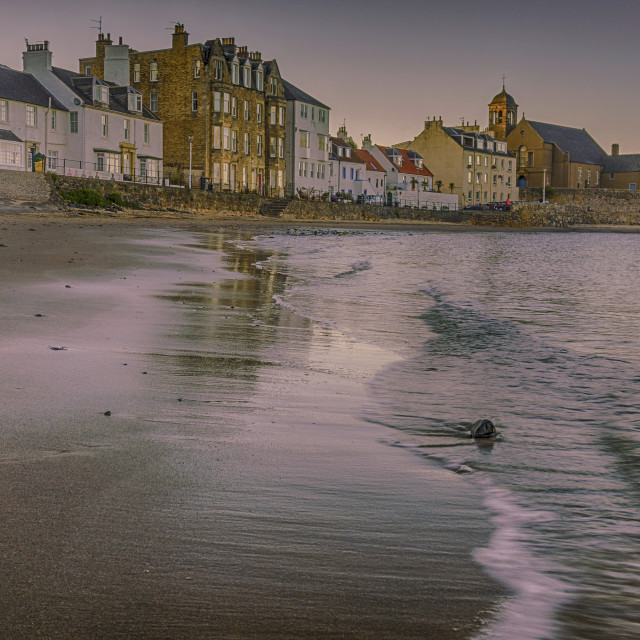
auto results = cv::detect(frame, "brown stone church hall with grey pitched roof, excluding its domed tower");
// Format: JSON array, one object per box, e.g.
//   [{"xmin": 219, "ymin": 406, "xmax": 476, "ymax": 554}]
[{"xmin": 507, "ymin": 116, "xmax": 606, "ymax": 189}]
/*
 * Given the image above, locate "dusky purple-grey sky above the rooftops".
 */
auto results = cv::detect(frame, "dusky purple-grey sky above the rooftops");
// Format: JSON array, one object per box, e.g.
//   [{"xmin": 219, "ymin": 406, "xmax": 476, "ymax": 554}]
[{"xmin": 0, "ymin": 0, "xmax": 640, "ymax": 153}]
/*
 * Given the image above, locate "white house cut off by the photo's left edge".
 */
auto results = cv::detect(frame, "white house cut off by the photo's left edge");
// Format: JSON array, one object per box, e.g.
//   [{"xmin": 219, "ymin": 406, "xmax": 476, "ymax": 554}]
[{"xmin": 0, "ymin": 65, "xmax": 69, "ymax": 171}]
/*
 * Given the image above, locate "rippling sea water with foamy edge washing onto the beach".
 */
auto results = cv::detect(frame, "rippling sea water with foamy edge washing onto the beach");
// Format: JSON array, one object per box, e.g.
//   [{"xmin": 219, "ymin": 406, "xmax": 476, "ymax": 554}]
[{"xmin": 249, "ymin": 229, "xmax": 640, "ymax": 640}]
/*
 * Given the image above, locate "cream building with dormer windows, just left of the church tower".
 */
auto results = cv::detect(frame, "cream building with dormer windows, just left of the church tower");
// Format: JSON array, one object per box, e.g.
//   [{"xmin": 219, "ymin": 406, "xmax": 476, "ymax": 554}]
[{"xmin": 402, "ymin": 118, "xmax": 518, "ymax": 207}]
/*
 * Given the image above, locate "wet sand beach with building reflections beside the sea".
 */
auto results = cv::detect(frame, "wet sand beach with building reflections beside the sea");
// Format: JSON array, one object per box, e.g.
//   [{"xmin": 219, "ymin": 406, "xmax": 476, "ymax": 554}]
[{"xmin": 0, "ymin": 215, "xmax": 505, "ymax": 640}]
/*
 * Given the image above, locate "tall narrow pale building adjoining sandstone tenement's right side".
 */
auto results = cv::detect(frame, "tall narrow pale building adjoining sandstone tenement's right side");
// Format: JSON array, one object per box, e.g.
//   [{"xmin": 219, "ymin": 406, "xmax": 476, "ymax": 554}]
[{"xmin": 282, "ymin": 80, "xmax": 331, "ymax": 198}]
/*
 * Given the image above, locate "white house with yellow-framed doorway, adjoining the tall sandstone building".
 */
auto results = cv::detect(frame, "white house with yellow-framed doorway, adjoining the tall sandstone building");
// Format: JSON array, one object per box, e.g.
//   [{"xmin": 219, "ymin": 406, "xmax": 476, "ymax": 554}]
[{"xmin": 22, "ymin": 41, "xmax": 162, "ymax": 182}]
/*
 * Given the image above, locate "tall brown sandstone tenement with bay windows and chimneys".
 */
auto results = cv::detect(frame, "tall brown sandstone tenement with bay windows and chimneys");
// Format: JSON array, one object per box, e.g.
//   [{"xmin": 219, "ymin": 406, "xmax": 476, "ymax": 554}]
[{"xmin": 80, "ymin": 24, "xmax": 286, "ymax": 195}]
